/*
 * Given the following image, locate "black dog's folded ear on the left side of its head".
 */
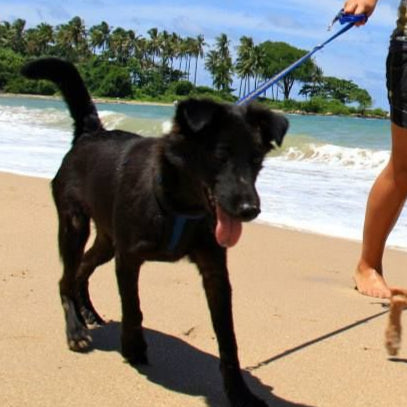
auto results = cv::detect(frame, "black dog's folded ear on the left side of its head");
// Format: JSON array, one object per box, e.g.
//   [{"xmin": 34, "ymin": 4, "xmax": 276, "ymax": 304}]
[{"xmin": 175, "ymin": 99, "xmax": 219, "ymax": 134}]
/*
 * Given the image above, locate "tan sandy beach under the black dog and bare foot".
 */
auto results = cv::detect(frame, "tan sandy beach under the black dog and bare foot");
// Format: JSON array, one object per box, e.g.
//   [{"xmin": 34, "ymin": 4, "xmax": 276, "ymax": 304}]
[{"xmin": 0, "ymin": 173, "xmax": 407, "ymax": 407}]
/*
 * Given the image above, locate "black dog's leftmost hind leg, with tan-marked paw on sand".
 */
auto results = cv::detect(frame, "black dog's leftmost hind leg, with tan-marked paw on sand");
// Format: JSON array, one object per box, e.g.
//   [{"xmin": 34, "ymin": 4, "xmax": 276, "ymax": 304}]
[{"xmin": 58, "ymin": 207, "xmax": 91, "ymax": 352}]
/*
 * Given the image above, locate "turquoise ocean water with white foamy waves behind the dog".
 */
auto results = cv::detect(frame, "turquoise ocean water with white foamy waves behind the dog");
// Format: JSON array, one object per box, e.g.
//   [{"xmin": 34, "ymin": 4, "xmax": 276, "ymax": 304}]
[{"xmin": 0, "ymin": 97, "xmax": 407, "ymax": 249}]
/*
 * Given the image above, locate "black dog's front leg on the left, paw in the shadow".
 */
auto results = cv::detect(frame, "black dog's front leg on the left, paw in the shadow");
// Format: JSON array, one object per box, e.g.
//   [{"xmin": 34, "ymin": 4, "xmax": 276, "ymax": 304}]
[{"xmin": 116, "ymin": 253, "xmax": 148, "ymax": 365}]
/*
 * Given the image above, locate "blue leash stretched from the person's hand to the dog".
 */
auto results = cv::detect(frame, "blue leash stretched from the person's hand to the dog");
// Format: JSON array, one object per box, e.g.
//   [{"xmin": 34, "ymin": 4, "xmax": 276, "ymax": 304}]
[{"xmin": 236, "ymin": 10, "xmax": 367, "ymax": 106}]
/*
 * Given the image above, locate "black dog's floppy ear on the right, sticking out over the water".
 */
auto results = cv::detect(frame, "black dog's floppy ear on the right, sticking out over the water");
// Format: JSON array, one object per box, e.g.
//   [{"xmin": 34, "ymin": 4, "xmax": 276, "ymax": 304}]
[{"xmin": 247, "ymin": 104, "xmax": 289, "ymax": 149}]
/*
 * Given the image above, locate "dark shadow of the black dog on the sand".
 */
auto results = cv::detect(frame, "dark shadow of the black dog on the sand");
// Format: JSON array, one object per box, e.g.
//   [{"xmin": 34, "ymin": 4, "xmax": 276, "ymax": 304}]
[{"xmin": 91, "ymin": 322, "xmax": 307, "ymax": 407}]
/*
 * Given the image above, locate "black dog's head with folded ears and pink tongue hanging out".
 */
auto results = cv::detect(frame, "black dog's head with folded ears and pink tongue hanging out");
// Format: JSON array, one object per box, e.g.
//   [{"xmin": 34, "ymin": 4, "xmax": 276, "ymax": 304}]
[{"xmin": 173, "ymin": 99, "xmax": 288, "ymax": 246}]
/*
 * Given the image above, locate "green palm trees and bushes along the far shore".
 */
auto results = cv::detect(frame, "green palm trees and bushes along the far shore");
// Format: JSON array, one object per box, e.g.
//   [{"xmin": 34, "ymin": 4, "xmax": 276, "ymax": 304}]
[{"xmin": 0, "ymin": 17, "xmax": 387, "ymax": 117}]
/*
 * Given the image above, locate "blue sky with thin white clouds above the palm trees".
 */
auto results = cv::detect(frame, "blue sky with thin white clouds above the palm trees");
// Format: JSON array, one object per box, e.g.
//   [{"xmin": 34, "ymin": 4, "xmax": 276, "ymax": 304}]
[{"xmin": 0, "ymin": 0, "xmax": 399, "ymax": 110}]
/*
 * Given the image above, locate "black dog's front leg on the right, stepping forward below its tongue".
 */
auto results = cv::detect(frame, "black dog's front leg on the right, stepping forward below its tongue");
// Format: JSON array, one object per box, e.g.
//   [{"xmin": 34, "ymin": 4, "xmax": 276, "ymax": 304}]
[{"xmin": 191, "ymin": 245, "xmax": 266, "ymax": 407}]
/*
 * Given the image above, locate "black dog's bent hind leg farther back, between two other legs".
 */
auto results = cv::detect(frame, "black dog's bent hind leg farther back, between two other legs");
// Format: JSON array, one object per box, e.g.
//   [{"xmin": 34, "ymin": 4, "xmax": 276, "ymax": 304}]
[{"xmin": 76, "ymin": 232, "xmax": 114, "ymax": 326}]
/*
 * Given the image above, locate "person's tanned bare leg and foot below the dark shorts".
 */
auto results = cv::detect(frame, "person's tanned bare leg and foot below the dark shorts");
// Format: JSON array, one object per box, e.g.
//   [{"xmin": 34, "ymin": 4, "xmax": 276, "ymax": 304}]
[{"xmin": 354, "ymin": 123, "xmax": 407, "ymax": 298}]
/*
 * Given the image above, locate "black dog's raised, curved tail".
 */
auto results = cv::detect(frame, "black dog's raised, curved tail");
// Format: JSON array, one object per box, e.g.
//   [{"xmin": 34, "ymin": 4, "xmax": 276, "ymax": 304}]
[{"xmin": 21, "ymin": 58, "xmax": 103, "ymax": 144}]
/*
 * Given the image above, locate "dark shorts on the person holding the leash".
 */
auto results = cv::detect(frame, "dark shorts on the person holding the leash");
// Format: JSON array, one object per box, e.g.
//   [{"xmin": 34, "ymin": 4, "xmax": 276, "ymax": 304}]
[{"xmin": 386, "ymin": 39, "xmax": 407, "ymax": 128}]
